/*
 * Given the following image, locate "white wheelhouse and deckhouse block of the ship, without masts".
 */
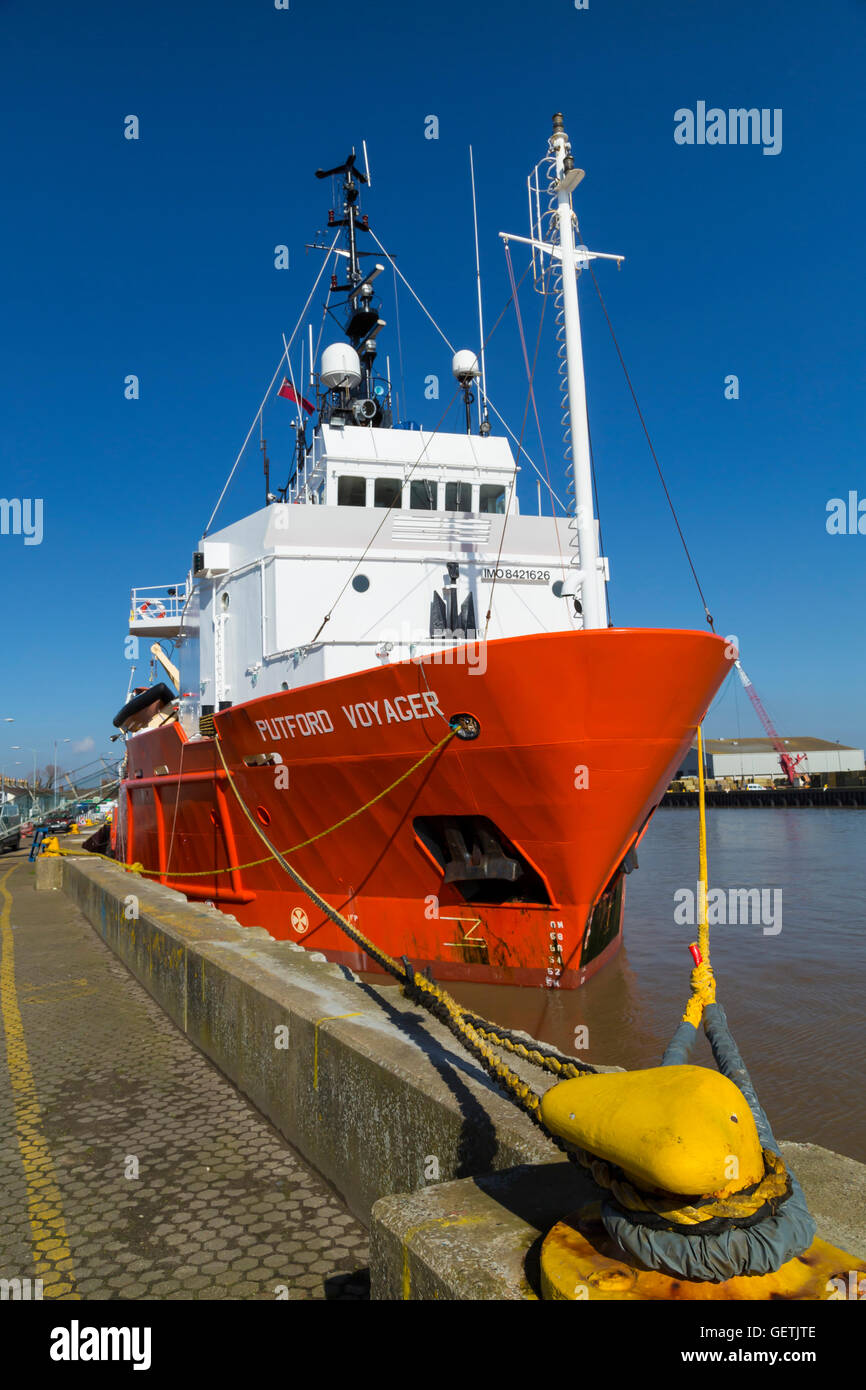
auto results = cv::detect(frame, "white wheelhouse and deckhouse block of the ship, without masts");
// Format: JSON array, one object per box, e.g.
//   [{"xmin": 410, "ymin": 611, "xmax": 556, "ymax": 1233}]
[{"xmin": 145, "ymin": 424, "xmax": 582, "ymax": 733}]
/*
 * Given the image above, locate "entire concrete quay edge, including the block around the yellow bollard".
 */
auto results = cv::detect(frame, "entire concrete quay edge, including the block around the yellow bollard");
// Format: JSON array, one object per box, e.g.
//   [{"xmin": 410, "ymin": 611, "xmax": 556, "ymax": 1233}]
[{"xmin": 48, "ymin": 856, "xmax": 866, "ymax": 1301}]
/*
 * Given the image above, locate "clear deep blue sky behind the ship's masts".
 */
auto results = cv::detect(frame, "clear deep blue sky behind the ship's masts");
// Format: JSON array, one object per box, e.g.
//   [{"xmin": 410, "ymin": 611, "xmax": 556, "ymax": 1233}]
[{"xmin": 0, "ymin": 0, "xmax": 866, "ymax": 771}]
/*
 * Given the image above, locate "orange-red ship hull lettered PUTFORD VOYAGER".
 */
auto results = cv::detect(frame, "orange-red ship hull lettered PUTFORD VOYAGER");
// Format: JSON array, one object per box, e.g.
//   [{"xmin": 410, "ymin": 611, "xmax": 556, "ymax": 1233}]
[{"xmin": 118, "ymin": 628, "xmax": 730, "ymax": 988}]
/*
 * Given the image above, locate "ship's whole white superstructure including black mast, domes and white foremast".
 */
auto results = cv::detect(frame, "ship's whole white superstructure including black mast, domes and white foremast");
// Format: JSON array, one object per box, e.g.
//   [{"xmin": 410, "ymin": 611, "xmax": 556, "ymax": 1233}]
[{"xmin": 131, "ymin": 118, "xmax": 617, "ymax": 734}]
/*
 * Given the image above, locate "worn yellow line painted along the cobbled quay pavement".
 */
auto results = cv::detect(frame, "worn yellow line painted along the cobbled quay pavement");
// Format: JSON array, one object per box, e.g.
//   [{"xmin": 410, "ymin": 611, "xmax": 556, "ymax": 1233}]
[{"xmin": 0, "ymin": 869, "xmax": 79, "ymax": 1298}]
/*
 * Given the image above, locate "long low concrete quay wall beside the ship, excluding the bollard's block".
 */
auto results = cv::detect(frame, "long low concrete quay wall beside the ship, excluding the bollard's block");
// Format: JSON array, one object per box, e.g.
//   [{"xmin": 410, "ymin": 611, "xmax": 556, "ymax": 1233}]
[{"xmin": 57, "ymin": 856, "xmax": 560, "ymax": 1223}]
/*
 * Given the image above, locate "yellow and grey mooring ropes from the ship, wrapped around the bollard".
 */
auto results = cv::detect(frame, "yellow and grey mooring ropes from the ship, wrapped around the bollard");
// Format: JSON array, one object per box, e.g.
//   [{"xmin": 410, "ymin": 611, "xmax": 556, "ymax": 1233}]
[{"xmin": 42, "ymin": 721, "xmax": 815, "ymax": 1282}]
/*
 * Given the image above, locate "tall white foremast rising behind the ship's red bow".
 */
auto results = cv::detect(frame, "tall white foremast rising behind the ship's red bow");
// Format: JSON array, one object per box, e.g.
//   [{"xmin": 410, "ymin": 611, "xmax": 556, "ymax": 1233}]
[{"xmin": 550, "ymin": 114, "xmax": 607, "ymax": 627}]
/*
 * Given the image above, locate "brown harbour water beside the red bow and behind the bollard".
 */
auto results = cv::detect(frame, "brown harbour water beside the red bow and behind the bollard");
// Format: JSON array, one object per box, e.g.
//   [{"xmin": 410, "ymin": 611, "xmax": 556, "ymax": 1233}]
[{"xmin": 380, "ymin": 808, "xmax": 866, "ymax": 1161}]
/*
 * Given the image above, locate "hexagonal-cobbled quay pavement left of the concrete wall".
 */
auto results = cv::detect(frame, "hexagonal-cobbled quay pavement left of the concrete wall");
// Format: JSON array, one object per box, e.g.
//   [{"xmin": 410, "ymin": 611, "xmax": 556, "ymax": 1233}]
[{"xmin": 0, "ymin": 853, "xmax": 368, "ymax": 1300}]
